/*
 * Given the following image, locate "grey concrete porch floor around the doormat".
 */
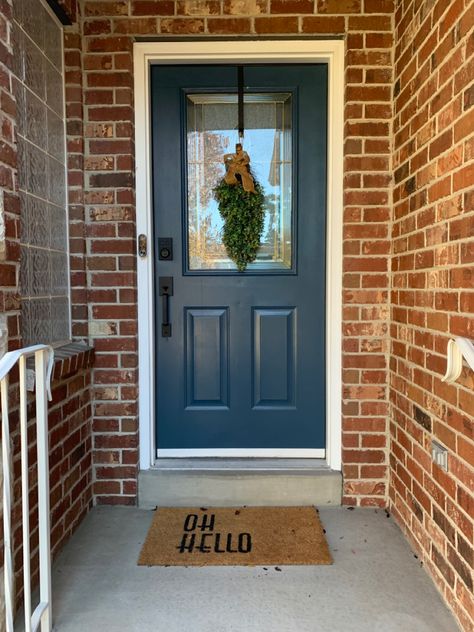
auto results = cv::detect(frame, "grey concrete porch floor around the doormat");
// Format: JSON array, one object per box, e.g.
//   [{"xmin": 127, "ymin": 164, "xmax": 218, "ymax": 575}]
[{"xmin": 27, "ymin": 507, "xmax": 458, "ymax": 632}]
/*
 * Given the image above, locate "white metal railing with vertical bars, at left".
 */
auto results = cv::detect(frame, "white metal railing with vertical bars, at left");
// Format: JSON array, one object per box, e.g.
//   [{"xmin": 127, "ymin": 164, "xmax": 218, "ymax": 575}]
[{"xmin": 0, "ymin": 345, "xmax": 54, "ymax": 632}]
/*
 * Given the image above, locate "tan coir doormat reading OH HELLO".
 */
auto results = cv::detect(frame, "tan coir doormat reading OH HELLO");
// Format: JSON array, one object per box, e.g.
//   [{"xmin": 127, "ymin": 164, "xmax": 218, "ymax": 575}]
[{"xmin": 138, "ymin": 507, "xmax": 332, "ymax": 566}]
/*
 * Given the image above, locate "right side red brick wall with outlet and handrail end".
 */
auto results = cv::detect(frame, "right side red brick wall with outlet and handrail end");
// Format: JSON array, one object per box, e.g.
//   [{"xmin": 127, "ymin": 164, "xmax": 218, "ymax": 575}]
[{"xmin": 390, "ymin": 0, "xmax": 474, "ymax": 630}]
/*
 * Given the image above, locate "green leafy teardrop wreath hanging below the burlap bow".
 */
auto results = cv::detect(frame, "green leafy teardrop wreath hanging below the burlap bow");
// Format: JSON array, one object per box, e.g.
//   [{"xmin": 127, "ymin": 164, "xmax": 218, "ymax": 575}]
[{"xmin": 214, "ymin": 176, "xmax": 265, "ymax": 272}]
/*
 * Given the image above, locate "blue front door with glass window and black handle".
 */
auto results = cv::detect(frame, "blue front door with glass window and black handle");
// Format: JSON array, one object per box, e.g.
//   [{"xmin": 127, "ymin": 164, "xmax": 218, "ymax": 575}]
[{"xmin": 151, "ymin": 64, "xmax": 327, "ymax": 456}]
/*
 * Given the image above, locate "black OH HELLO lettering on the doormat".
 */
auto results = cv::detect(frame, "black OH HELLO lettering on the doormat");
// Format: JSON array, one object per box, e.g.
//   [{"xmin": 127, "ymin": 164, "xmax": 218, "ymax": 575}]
[{"xmin": 176, "ymin": 513, "xmax": 252, "ymax": 554}]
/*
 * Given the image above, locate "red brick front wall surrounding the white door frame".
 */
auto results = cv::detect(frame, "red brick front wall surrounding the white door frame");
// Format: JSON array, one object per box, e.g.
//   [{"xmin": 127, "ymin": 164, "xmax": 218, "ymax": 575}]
[{"xmin": 78, "ymin": 0, "xmax": 393, "ymax": 506}]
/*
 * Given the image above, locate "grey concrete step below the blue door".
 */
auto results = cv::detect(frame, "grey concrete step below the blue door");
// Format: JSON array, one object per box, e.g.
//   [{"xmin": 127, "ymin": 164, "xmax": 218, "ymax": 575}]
[{"xmin": 138, "ymin": 459, "xmax": 342, "ymax": 509}]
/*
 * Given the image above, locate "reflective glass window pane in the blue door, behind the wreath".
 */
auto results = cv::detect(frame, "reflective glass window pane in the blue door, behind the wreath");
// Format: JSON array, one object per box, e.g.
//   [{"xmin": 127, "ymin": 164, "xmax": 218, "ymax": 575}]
[{"xmin": 187, "ymin": 93, "xmax": 292, "ymax": 271}]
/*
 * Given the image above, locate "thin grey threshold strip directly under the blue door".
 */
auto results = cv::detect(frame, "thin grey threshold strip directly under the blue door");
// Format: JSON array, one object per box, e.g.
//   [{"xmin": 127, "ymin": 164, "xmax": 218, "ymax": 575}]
[{"xmin": 151, "ymin": 457, "xmax": 329, "ymax": 472}]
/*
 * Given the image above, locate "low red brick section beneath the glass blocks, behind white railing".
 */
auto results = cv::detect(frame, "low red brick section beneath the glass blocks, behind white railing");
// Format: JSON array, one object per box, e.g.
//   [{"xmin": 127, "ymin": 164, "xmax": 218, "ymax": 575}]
[{"xmin": 11, "ymin": 351, "xmax": 92, "ymax": 601}]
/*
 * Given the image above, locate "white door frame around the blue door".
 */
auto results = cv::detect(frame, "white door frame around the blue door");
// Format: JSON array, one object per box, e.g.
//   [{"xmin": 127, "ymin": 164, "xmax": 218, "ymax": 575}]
[{"xmin": 133, "ymin": 40, "xmax": 344, "ymax": 470}]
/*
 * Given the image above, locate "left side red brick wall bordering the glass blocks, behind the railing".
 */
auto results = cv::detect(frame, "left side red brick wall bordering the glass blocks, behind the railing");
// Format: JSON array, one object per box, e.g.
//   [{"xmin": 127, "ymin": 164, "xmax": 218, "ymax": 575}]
[{"xmin": 0, "ymin": 0, "xmax": 92, "ymax": 599}]
